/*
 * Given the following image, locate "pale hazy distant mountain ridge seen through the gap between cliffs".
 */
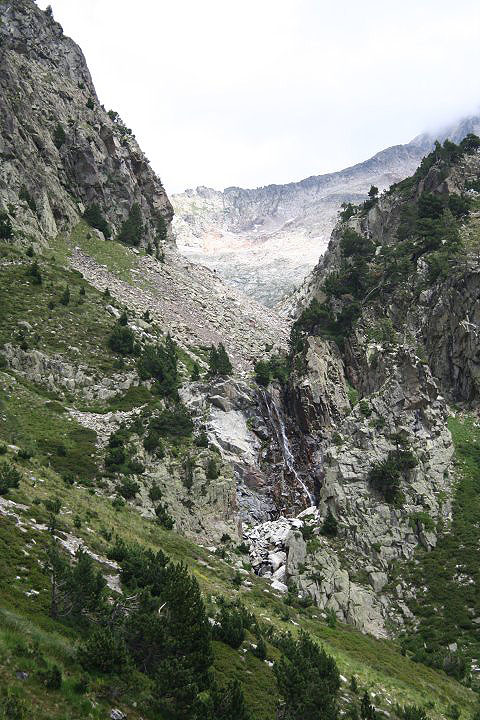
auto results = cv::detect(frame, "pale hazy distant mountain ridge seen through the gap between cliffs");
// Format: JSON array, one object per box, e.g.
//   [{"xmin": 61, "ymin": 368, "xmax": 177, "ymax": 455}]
[{"xmin": 172, "ymin": 116, "xmax": 480, "ymax": 307}]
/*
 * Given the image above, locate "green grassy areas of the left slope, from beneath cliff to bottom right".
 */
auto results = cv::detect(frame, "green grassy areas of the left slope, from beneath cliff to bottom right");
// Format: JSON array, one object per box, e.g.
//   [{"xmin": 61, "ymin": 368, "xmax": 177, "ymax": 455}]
[{"xmin": 0, "ymin": 233, "xmax": 473, "ymax": 720}]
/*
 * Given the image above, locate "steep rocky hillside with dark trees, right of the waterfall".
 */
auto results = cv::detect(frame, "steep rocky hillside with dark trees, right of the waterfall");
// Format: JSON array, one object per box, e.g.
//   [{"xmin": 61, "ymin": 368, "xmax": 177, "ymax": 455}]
[{"xmin": 268, "ymin": 135, "xmax": 480, "ymax": 686}]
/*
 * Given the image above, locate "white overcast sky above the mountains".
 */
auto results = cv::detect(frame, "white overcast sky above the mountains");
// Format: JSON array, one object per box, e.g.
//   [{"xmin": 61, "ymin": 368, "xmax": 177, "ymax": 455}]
[{"xmin": 38, "ymin": 0, "xmax": 480, "ymax": 192}]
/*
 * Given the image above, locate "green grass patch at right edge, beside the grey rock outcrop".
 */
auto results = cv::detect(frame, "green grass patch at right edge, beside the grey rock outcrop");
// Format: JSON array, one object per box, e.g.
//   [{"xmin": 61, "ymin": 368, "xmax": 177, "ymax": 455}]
[{"xmin": 406, "ymin": 416, "xmax": 480, "ymax": 683}]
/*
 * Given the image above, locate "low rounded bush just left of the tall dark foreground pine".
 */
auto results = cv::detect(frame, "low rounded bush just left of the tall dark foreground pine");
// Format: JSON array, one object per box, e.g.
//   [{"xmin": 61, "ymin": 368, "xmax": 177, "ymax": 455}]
[{"xmin": 77, "ymin": 627, "xmax": 128, "ymax": 673}]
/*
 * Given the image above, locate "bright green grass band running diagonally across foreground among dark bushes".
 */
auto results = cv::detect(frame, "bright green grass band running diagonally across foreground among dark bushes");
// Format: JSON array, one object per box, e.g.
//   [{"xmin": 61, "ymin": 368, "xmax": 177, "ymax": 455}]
[{"xmin": 0, "ymin": 444, "xmax": 474, "ymax": 720}]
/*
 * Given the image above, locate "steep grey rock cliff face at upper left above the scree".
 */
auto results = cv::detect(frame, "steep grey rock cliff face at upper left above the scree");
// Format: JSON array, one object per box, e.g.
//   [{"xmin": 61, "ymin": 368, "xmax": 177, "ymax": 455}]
[{"xmin": 0, "ymin": 0, "xmax": 173, "ymax": 244}]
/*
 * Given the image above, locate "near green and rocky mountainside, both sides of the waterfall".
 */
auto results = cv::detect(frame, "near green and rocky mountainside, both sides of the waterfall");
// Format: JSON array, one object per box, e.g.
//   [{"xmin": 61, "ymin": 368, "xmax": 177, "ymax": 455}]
[{"xmin": 0, "ymin": 0, "xmax": 480, "ymax": 720}]
